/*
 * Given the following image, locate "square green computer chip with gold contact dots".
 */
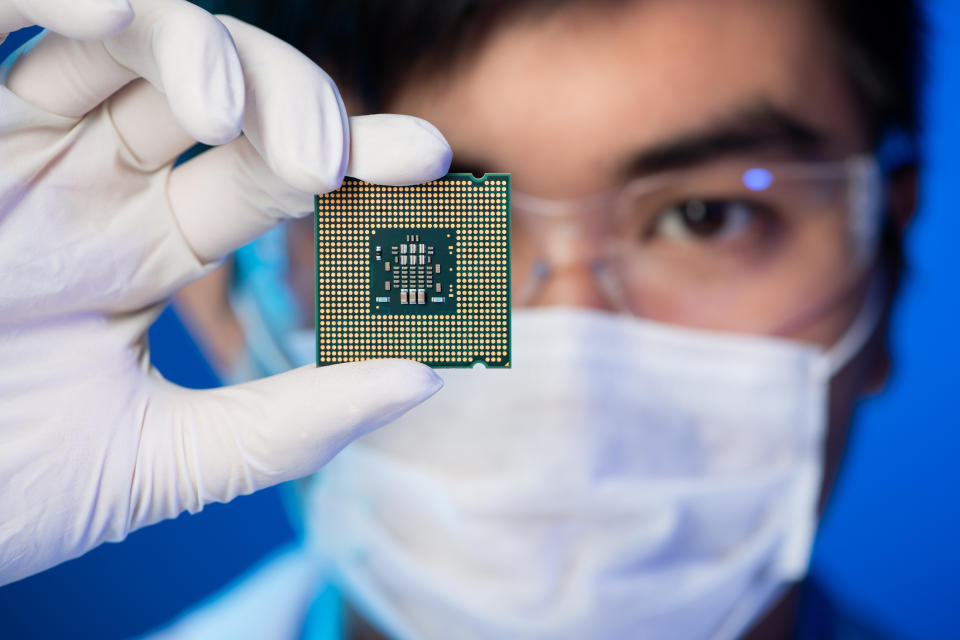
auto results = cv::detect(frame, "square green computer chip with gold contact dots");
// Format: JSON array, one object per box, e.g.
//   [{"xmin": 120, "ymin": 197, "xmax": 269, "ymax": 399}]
[{"xmin": 314, "ymin": 173, "xmax": 510, "ymax": 367}]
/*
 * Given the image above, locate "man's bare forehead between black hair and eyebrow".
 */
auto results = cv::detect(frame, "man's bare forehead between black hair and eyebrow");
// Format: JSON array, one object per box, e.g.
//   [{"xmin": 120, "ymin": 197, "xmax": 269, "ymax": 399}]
[{"xmin": 391, "ymin": 0, "xmax": 861, "ymax": 197}]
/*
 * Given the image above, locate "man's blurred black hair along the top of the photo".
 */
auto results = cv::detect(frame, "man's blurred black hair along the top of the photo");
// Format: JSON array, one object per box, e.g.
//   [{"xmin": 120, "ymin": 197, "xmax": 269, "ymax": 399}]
[{"xmin": 197, "ymin": 0, "xmax": 924, "ymax": 139}]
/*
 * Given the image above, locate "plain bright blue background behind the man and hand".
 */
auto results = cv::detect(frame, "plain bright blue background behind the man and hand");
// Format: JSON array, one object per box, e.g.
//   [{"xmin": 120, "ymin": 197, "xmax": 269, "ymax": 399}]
[{"xmin": 0, "ymin": 6, "xmax": 960, "ymax": 638}]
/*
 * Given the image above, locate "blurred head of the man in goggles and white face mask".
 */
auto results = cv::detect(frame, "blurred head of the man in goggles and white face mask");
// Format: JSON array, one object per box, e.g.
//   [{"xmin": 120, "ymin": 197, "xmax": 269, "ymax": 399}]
[{"xmin": 163, "ymin": 0, "xmax": 919, "ymax": 638}]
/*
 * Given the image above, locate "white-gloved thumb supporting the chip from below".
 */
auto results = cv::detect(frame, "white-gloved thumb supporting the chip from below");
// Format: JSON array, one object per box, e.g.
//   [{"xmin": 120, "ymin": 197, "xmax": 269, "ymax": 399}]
[{"xmin": 128, "ymin": 360, "xmax": 443, "ymax": 531}]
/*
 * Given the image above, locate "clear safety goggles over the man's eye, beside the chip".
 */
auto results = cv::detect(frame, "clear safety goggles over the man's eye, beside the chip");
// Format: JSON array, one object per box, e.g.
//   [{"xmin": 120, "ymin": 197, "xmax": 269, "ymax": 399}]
[{"xmin": 512, "ymin": 148, "xmax": 896, "ymax": 333}]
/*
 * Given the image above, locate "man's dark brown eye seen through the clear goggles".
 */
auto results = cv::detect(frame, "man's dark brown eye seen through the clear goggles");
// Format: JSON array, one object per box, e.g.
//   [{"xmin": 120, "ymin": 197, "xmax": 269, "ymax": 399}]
[{"xmin": 644, "ymin": 198, "xmax": 778, "ymax": 243}]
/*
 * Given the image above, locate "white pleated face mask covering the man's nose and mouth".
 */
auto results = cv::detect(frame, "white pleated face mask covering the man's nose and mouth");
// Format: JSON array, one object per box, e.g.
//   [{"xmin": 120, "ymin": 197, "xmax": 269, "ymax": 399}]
[{"xmin": 305, "ymin": 296, "xmax": 879, "ymax": 640}]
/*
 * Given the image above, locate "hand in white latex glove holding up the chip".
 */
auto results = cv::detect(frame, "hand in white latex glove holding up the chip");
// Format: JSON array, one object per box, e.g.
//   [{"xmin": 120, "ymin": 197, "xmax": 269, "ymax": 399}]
[{"xmin": 0, "ymin": 0, "xmax": 450, "ymax": 584}]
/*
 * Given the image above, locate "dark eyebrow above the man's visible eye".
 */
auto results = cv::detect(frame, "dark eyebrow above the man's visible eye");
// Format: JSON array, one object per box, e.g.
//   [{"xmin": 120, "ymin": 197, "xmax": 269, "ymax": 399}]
[{"xmin": 622, "ymin": 101, "xmax": 826, "ymax": 178}]
